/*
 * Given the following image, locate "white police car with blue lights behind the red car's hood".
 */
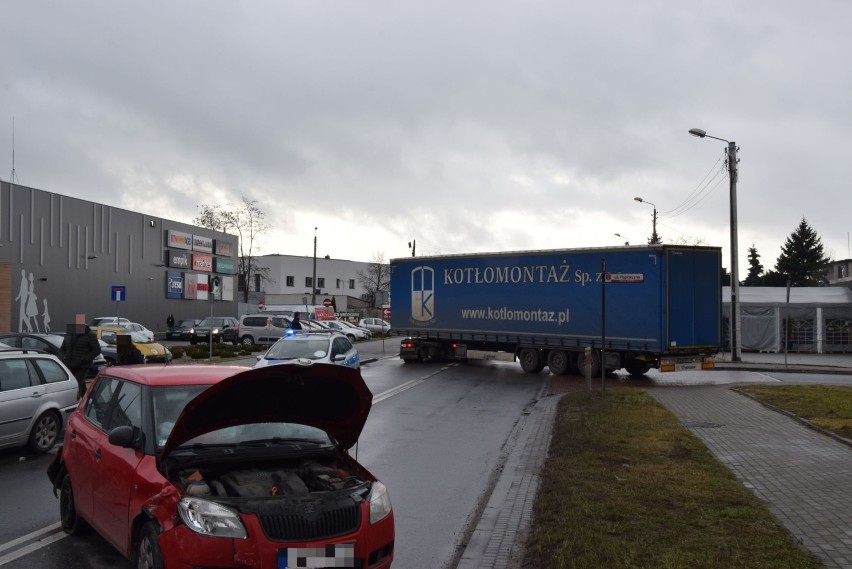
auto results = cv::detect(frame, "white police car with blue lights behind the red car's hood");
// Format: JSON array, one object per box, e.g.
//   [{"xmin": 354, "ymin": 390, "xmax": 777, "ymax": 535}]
[{"xmin": 254, "ymin": 330, "xmax": 361, "ymax": 371}]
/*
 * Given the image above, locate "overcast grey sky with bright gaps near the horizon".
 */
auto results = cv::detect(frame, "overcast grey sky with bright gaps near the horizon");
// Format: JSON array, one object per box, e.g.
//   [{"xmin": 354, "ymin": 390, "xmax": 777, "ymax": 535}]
[{"xmin": 0, "ymin": 0, "xmax": 852, "ymax": 270}]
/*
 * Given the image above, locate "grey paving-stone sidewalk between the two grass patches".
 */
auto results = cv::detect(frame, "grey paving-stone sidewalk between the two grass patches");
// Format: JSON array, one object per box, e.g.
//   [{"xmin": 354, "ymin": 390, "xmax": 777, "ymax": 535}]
[{"xmin": 649, "ymin": 386, "xmax": 852, "ymax": 568}]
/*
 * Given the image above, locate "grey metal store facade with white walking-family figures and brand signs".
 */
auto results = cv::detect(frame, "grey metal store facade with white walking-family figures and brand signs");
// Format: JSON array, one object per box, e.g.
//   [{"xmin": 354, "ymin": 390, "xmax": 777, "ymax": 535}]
[{"xmin": 0, "ymin": 181, "xmax": 239, "ymax": 332}]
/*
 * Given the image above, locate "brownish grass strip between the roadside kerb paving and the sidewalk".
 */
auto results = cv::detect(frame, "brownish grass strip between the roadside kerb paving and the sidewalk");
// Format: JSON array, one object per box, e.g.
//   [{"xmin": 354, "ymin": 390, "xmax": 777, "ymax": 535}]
[{"xmin": 524, "ymin": 387, "xmax": 822, "ymax": 569}]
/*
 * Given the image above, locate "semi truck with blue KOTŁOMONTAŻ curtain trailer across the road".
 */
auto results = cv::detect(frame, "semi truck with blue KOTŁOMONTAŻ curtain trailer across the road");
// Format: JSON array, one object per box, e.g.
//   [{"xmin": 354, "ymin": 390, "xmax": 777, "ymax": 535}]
[{"xmin": 390, "ymin": 244, "xmax": 722, "ymax": 376}]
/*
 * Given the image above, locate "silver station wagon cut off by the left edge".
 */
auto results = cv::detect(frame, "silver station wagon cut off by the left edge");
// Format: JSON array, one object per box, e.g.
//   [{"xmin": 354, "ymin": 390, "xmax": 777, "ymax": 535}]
[{"xmin": 0, "ymin": 348, "xmax": 79, "ymax": 453}]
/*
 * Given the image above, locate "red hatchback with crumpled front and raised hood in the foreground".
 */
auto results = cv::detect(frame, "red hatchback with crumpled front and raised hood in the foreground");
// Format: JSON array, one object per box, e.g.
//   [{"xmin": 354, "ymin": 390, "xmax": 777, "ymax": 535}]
[{"xmin": 48, "ymin": 364, "xmax": 394, "ymax": 569}]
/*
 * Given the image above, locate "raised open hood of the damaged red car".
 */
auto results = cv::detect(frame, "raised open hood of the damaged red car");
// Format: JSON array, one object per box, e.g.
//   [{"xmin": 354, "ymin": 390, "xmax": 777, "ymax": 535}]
[{"xmin": 160, "ymin": 364, "xmax": 373, "ymax": 452}]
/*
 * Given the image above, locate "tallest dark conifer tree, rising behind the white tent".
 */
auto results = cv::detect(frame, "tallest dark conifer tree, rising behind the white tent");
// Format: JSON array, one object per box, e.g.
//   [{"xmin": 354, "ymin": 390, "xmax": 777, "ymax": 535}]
[{"xmin": 775, "ymin": 217, "xmax": 831, "ymax": 286}]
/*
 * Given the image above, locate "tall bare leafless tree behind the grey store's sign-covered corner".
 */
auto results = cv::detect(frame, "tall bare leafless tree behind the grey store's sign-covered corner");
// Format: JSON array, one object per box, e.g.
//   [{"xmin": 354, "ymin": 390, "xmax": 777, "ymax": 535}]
[{"xmin": 193, "ymin": 196, "xmax": 271, "ymax": 302}]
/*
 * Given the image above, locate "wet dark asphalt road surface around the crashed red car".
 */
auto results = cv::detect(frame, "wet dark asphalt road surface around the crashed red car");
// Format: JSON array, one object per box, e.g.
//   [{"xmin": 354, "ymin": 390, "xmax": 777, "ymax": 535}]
[{"xmin": 0, "ymin": 354, "xmax": 545, "ymax": 569}]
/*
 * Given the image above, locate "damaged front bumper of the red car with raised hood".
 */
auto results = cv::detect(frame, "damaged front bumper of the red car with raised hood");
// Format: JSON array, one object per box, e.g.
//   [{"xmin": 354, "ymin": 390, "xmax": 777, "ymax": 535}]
[{"xmin": 160, "ymin": 504, "xmax": 394, "ymax": 569}]
